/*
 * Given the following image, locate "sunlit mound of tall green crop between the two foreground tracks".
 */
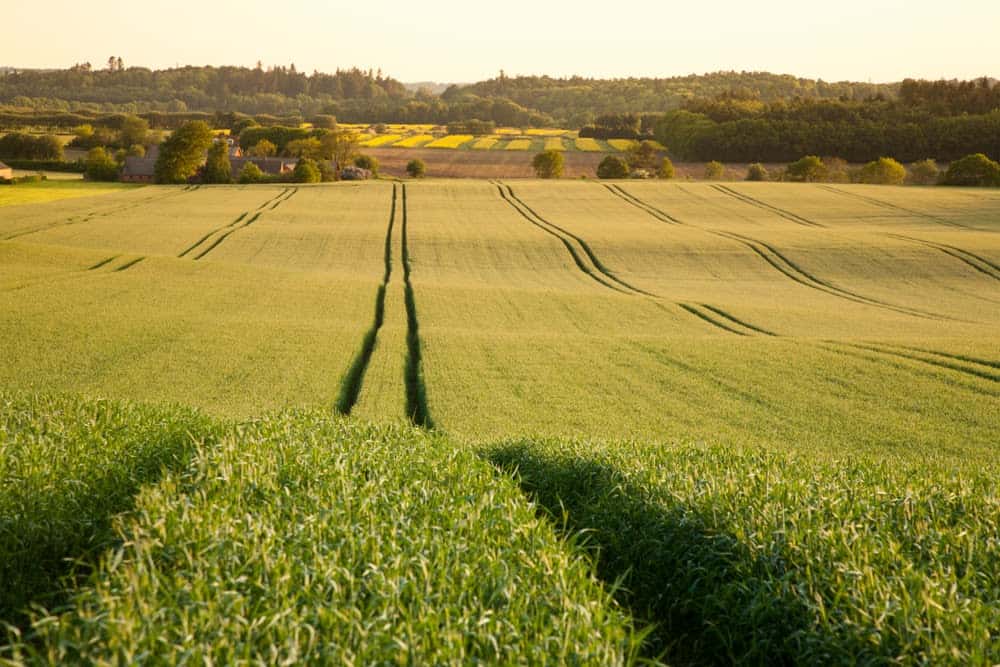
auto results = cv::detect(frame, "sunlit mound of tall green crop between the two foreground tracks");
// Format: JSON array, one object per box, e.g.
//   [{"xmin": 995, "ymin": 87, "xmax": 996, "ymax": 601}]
[{"xmin": 0, "ymin": 404, "xmax": 633, "ymax": 664}]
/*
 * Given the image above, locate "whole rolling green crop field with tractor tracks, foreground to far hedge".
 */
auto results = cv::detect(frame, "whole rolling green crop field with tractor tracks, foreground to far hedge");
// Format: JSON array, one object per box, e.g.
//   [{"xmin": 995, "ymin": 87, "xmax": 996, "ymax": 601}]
[{"xmin": 0, "ymin": 181, "xmax": 1000, "ymax": 664}]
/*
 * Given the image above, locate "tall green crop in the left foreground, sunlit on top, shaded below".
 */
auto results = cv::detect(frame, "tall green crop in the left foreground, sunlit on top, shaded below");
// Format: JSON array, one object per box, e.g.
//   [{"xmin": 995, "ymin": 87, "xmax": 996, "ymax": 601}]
[{"xmin": 0, "ymin": 393, "xmax": 214, "ymax": 622}]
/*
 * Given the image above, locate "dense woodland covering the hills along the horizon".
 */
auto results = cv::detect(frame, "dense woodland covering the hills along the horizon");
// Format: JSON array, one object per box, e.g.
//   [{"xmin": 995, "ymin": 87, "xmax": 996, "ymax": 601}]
[{"xmin": 0, "ymin": 64, "xmax": 1000, "ymax": 162}]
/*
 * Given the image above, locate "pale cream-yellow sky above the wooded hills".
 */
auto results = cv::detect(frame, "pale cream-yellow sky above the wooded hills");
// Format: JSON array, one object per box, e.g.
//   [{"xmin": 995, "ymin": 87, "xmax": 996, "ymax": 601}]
[{"xmin": 7, "ymin": 0, "xmax": 1000, "ymax": 82}]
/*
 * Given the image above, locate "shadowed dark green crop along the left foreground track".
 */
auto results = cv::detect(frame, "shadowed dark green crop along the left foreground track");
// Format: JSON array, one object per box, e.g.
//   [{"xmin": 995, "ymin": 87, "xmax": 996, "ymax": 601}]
[{"xmin": 0, "ymin": 402, "xmax": 220, "ymax": 636}]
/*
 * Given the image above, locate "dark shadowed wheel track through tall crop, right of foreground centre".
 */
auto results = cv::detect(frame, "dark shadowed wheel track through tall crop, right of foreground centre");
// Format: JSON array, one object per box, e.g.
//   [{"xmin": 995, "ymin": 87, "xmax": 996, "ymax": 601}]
[{"xmin": 486, "ymin": 444, "xmax": 828, "ymax": 665}]
